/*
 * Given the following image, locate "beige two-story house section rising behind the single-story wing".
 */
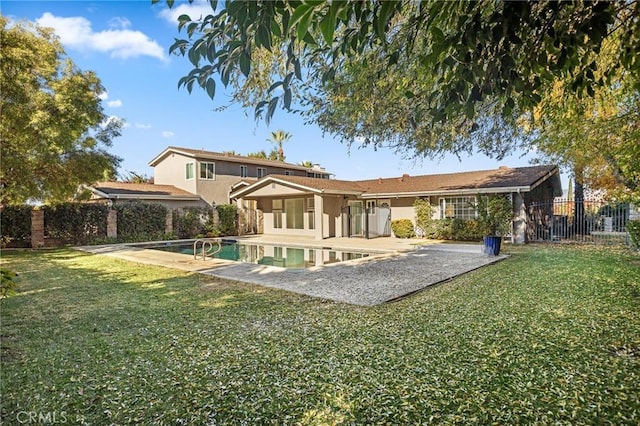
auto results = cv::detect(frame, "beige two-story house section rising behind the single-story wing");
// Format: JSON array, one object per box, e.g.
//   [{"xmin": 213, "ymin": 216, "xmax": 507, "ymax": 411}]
[{"xmin": 149, "ymin": 146, "xmax": 331, "ymax": 204}]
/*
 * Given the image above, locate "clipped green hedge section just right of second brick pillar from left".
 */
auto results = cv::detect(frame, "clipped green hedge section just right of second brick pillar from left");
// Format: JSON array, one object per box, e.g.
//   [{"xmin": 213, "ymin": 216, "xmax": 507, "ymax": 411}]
[{"xmin": 115, "ymin": 201, "xmax": 167, "ymax": 242}]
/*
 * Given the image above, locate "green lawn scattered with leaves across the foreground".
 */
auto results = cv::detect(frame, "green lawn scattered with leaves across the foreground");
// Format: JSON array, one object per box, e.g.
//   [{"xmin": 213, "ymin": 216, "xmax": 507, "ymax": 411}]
[{"xmin": 0, "ymin": 246, "xmax": 640, "ymax": 425}]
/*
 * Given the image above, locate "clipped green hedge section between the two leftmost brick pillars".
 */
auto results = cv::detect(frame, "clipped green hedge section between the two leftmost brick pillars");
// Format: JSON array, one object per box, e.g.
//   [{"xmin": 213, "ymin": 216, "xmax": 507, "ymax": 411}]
[{"xmin": 42, "ymin": 203, "xmax": 109, "ymax": 244}]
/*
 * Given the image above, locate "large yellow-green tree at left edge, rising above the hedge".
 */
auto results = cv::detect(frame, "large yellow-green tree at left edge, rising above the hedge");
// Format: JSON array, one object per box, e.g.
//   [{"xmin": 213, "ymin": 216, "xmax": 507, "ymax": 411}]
[{"xmin": 0, "ymin": 16, "xmax": 121, "ymax": 204}]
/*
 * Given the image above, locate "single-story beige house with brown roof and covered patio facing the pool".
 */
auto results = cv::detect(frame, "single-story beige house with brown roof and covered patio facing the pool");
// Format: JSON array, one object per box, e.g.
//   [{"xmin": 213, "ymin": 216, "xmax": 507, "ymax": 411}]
[{"xmin": 231, "ymin": 165, "xmax": 562, "ymax": 243}]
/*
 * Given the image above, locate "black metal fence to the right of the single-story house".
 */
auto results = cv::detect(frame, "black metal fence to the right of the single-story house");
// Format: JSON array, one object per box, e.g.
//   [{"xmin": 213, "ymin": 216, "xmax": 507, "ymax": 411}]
[{"xmin": 527, "ymin": 198, "xmax": 629, "ymax": 244}]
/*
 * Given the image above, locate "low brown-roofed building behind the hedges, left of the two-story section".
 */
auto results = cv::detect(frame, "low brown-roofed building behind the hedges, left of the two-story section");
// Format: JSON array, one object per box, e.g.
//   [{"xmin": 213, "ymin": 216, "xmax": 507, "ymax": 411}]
[{"xmin": 85, "ymin": 182, "xmax": 207, "ymax": 209}]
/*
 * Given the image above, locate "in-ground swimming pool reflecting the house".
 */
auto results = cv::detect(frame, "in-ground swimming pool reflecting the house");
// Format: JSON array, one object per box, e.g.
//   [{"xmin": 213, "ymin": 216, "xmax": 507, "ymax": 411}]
[{"xmin": 140, "ymin": 240, "xmax": 371, "ymax": 269}]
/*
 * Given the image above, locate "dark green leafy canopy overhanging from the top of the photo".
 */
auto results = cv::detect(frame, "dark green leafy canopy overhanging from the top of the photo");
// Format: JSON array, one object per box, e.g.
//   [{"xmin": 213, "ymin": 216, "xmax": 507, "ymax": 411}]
[{"xmin": 162, "ymin": 0, "xmax": 640, "ymax": 195}]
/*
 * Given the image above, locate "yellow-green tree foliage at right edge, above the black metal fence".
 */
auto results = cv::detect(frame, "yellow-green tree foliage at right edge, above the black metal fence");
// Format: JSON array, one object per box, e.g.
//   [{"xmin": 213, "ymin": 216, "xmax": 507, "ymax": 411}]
[{"xmin": 521, "ymin": 32, "xmax": 640, "ymax": 200}]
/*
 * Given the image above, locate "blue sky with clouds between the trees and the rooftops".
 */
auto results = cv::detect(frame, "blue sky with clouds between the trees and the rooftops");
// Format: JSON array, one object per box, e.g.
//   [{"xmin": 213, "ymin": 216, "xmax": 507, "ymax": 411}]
[{"xmin": 1, "ymin": 0, "xmax": 566, "ymax": 186}]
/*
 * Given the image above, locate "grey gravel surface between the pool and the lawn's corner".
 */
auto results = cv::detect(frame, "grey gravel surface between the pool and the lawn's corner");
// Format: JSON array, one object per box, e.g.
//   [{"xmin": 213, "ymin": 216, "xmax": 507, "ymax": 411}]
[{"xmin": 200, "ymin": 245, "xmax": 507, "ymax": 306}]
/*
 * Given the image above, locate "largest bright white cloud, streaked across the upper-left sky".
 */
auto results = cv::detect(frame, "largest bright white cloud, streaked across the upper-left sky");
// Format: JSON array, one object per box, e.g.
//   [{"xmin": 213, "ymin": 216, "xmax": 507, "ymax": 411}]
[{"xmin": 36, "ymin": 12, "xmax": 167, "ymax": 61}]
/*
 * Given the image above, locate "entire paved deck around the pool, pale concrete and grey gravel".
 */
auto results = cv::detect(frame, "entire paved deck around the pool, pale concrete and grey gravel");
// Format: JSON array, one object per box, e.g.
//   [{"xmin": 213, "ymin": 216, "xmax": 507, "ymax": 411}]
[{"xmin": 78, "ymin": 235, "xmax": 507, "ymax": 306}]
